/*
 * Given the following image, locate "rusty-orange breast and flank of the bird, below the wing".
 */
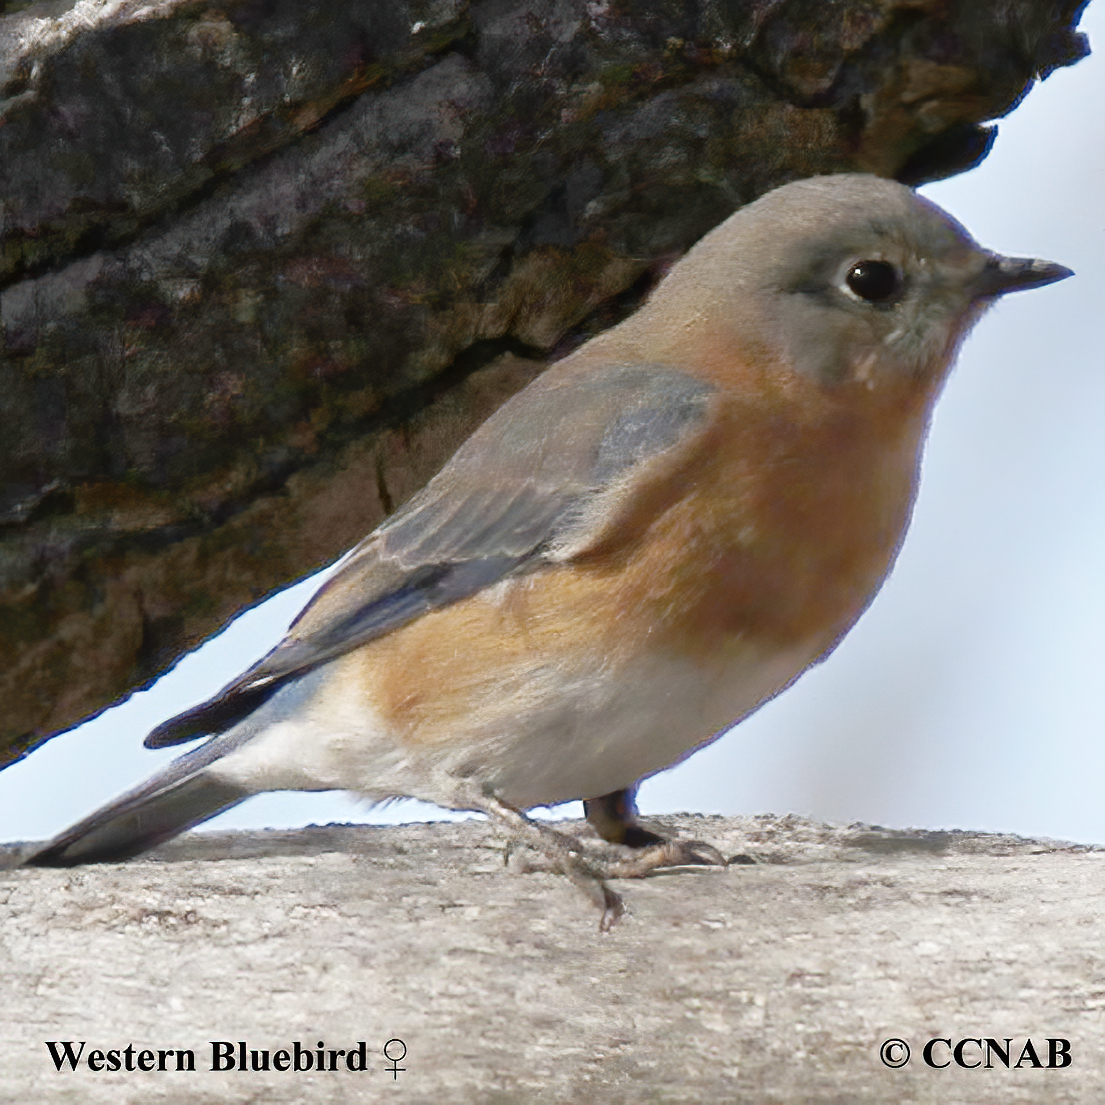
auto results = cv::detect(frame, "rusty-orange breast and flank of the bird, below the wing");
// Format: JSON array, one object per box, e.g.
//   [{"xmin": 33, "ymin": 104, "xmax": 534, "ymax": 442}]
[{"xmin": 354, "ymin": 358, "xmax": 925, "ymax": 741}]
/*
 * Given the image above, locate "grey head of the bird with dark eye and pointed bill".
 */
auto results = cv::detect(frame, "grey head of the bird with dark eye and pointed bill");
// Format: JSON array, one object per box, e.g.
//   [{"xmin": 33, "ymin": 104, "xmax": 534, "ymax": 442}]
[{"xmin": 642, "ymin": 173, "xmax": 1071, "ymax": 388}]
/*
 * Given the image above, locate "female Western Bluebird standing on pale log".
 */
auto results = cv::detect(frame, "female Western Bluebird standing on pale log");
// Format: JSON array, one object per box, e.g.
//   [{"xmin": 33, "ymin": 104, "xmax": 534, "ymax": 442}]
[{"xmin": 24, "ymin": 173, "xmax": 1073, "ymax": 930}]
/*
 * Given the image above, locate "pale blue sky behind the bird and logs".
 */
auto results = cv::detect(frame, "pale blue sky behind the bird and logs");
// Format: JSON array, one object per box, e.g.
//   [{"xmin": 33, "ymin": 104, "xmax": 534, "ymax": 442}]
[{"xmin": 0, "ymin": 3, "xmax": 1105, "ymax": 843}]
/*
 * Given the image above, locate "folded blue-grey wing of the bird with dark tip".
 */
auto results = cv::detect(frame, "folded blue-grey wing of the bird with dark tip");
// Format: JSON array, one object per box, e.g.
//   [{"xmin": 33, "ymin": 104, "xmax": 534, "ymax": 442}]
[{"xmin": 146, "ymin": 365, "xmax": 713, "ymax": 748}]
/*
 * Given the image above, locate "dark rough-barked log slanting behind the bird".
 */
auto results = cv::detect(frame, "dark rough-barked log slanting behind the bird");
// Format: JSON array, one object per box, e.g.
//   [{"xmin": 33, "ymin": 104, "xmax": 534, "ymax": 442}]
[{"xmin": 0, "ymin": 0, "xmax": 1085, "ymax": 760}]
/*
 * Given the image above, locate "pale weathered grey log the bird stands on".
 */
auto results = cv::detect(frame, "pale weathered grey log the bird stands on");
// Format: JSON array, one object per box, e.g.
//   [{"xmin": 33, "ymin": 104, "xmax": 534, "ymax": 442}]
[{"xmin": 0, "ymin": 817, "xmax": 1105, "ymax": 1105}]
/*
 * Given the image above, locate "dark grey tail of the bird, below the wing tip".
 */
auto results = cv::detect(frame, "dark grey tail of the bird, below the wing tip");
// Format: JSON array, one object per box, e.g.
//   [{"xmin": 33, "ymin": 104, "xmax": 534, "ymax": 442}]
[{"xmin": 23, "ymin": 737, "xmax": 253, "ymax": 867}]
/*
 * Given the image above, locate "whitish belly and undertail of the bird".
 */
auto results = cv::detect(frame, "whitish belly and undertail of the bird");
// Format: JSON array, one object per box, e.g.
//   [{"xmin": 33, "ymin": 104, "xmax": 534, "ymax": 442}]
[{"xmin": 212, "ymin": 648, "xmax": 815, "ymax": 809}]
